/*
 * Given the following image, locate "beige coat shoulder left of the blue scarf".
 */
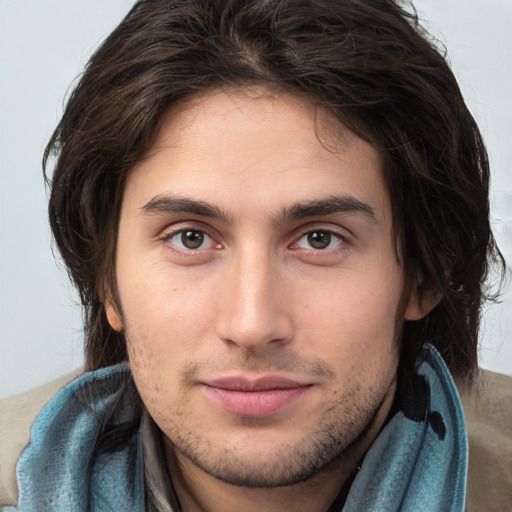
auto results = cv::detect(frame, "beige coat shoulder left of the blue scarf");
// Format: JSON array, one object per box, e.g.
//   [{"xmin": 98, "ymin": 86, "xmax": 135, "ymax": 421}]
[{"xmin": 0, "ymin": 371, "xmax": 82, "ymax": 506}]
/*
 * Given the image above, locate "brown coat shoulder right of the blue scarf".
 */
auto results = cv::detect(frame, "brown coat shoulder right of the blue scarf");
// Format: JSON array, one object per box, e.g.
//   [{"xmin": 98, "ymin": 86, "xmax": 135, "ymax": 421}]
[{"xmin": 461, "ymin": 370, "xmax": 512, "ymax": 512}]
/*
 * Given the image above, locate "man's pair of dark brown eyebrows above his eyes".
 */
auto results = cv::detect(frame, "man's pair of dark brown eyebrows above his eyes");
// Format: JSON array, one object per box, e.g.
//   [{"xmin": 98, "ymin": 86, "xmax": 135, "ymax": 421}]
[{"xmin": 141, "ymin": 195, "xmax": 378, "ymax": 224}]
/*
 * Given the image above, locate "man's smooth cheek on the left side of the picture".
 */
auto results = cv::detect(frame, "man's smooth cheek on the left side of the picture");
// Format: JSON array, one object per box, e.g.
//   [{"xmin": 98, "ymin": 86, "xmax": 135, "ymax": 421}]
[{"xmin": 118, "ymin": 265, "xmax": 221, "ymax": 410}]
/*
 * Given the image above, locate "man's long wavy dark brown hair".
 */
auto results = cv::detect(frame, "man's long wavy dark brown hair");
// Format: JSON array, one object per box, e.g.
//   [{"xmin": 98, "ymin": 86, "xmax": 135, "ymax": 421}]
[{"xmin": 43, "ymin": 0, "xmax": 503, "ymax": 377}]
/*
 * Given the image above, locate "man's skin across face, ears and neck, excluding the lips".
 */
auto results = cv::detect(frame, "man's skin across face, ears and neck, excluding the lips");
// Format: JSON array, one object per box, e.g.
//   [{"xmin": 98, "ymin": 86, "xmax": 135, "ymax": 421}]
[{"xmin": 106, "ymin": 89, "xmax": 426, "ymax": 512}]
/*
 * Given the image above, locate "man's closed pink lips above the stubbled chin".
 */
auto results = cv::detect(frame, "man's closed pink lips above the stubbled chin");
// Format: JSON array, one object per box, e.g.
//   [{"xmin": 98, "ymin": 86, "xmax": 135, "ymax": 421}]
[{"xmin": 204, "ymin": 376, "xmax": 311, "ymax": 418}]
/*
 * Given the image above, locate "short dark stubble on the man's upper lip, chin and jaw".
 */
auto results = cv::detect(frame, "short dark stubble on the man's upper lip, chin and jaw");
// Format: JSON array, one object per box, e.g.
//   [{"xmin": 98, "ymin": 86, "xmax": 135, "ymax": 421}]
[{"xmin": 128, "ymin": 338, "xmax": 394, "ymax": 489}]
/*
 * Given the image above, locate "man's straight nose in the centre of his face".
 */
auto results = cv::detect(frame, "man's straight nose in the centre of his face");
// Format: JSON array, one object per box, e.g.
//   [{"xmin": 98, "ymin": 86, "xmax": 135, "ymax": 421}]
[{"xmin": 217, "ymin": 250, "xmax": 293, "ymax": 351}]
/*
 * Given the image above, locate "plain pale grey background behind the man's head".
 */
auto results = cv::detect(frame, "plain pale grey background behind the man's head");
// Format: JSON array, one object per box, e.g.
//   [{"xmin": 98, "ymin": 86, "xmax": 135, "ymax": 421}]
[{"xmin": 0, "ymin": 0, "xmax": 512, "ymax": 397}]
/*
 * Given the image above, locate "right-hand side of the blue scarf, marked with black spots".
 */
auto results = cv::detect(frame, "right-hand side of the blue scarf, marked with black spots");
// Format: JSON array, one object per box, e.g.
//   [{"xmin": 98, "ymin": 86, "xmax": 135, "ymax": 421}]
[{"xmin": 343, "ymin": 345, "xmax": 468, "ymax": 512}]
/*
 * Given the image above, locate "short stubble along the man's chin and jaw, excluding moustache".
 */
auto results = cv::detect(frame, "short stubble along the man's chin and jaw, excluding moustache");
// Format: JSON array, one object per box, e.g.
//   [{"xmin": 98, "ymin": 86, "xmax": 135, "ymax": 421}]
[{"xmin": 162, "ymin": 376, "xmax": 391, "ymax": 489}]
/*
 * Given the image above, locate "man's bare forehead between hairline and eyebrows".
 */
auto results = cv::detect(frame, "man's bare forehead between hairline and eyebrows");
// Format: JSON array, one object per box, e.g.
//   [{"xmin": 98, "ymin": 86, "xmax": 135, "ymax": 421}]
[{"xmin": 125, "ymin": 89, "xmax": 389, "ymax": 222}]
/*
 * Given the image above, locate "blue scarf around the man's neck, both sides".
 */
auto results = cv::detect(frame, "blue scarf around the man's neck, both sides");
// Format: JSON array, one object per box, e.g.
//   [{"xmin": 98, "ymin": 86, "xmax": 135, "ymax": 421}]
[{"xmin": 9, "ymin": 346, "xmax": 467, "ymax": 512}]
